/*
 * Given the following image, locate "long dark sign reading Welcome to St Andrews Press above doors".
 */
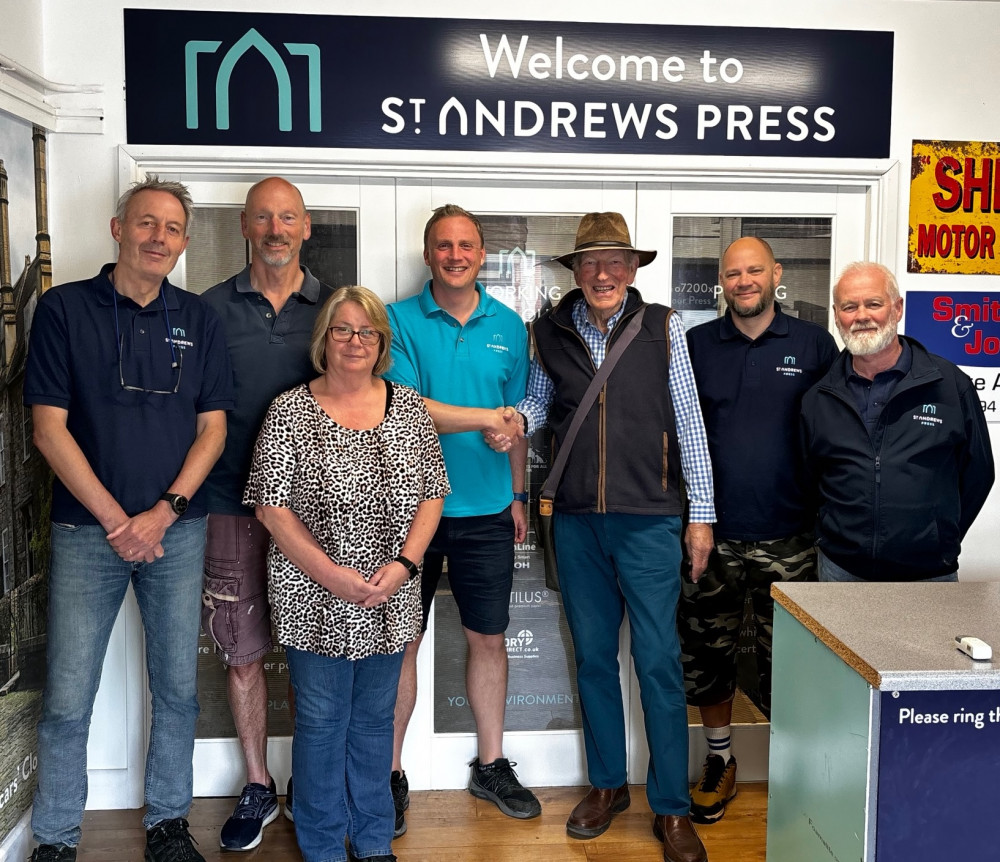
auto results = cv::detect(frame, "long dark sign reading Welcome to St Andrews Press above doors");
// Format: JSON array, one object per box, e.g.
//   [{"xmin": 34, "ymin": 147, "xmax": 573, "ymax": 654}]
[{"xmin": 124, "ymin": 9, "xmax": 893, "ymax": 158}]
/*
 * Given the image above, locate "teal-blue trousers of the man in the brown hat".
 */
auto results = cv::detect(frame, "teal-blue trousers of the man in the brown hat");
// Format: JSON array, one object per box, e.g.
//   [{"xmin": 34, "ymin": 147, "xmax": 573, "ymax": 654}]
[{"xmin": 554, "ymin": 512, "xmax": 691, "ymax": 815}]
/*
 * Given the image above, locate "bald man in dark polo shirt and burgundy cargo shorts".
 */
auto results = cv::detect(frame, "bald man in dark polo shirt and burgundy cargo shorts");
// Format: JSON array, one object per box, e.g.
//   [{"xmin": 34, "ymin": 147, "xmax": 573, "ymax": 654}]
[{"xmin": 202, "ymin": 177, "xmax": 333, "ymax": 850}]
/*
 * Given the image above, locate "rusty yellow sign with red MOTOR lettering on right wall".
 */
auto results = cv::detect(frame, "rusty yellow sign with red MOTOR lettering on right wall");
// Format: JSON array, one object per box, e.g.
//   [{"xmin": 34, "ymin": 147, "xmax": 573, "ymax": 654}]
[{"xmin": 906, "ymin": 141, "xmax": 1000, "ymax": 275}]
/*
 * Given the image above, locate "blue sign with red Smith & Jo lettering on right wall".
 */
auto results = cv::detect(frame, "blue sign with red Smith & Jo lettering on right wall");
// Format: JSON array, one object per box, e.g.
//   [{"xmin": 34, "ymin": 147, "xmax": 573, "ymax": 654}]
[{"xmin": 904, "ymin": 290, "xmax": 1000, "ymax": 368}]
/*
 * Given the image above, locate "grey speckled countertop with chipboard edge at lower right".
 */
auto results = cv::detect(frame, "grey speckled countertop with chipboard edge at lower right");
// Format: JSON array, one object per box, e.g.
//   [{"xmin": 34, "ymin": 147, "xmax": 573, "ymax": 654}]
[{"xmin": 771, "ymin": 581, "xmax": 1000, "ymax": 691}]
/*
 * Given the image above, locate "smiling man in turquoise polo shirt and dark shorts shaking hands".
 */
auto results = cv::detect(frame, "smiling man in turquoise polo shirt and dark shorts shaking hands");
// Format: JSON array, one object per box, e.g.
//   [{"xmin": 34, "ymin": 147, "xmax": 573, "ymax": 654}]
[{"xmin": 387, "ymin": 204, "xmax": 541, "ymax": 834}]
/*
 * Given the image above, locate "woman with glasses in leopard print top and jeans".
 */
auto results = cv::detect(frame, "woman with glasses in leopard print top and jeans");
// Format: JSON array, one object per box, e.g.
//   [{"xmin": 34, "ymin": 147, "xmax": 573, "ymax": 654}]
[{"xmin": 244, "ymin": 286, "xmax": 450, "ymax": 862}]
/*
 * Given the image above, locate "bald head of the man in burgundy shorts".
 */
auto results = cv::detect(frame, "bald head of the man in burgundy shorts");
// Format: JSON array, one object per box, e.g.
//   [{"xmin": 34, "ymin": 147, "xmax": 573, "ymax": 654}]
[{"xmin": 240, "ymin": 177, "xmax": 312, "ymax": 268}]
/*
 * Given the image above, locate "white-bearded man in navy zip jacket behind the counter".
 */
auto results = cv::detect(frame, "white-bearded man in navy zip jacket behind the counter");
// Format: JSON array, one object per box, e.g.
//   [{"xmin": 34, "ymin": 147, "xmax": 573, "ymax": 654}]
[{"xmin": 801, "ymin": 262, "xmax": 995, "ymax": 581}]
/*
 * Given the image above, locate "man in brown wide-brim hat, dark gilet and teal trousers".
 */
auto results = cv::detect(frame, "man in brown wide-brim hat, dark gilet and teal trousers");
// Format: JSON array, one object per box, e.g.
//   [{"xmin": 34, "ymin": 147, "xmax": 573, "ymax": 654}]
[{"xmin": 517, "ymin": 212, "xmax": 715, "ymax": 862}]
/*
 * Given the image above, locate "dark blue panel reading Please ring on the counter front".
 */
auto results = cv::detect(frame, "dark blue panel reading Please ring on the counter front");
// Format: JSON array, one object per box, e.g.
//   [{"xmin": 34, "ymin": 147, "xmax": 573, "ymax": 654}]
[{"xmin": 875, "ymin": 688, "xmax": 1000, "ymax": 862}]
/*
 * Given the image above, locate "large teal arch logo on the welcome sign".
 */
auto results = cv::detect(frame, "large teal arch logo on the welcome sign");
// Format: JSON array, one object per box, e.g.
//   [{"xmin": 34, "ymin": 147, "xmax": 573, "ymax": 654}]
[{"xmin": 184, "ymin": 27, "xmax": 323, "ymax": 132}]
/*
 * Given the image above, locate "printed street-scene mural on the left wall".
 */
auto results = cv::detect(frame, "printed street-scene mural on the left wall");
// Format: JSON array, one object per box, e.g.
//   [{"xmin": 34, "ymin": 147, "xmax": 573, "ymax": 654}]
[{"xmin": 0, "ymin": 111, "xmax": 52, "ymax": 850}]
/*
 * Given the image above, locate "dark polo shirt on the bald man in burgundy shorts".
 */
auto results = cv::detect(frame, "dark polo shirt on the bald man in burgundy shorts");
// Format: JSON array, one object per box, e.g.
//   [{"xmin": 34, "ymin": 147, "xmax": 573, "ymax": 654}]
[{"xmin": 201, "ymin": 266, "xmax": 333, "ymax": 515}]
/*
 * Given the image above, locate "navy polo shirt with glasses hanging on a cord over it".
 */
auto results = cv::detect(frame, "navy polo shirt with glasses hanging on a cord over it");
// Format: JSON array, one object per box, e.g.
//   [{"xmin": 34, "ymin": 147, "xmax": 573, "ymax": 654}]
[{"xmin": 24, "ymin": 264, "xmax": 233, "ymax": 524}]
